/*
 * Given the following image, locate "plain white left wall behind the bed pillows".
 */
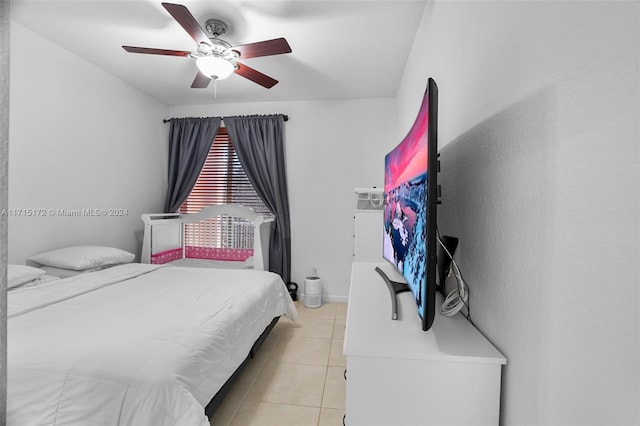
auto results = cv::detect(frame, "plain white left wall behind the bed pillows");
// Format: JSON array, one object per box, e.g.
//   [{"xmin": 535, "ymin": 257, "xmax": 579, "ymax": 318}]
[{"xmin": 9, "ymin": 21, "xmax": 168, "ymax": 263}]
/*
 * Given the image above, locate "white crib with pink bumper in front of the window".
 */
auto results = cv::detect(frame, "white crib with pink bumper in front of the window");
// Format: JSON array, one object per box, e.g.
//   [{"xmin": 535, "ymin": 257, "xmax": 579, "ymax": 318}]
[{"xmin": 140, "ymin": 204, "xmax": 274, "ymax": 271}]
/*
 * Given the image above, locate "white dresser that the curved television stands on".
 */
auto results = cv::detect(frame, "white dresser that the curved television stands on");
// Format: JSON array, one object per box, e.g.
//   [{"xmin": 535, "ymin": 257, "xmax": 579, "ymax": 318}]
[{"xmin": 343, "ymin": 262, "xmax": 506, "ymax": 426}]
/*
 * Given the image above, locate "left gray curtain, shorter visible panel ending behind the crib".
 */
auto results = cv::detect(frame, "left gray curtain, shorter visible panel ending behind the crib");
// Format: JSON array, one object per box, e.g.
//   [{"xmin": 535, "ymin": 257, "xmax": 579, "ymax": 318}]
[{"xmin": 164, "ymin": 117, "xmax": 222, "ymax": 213}]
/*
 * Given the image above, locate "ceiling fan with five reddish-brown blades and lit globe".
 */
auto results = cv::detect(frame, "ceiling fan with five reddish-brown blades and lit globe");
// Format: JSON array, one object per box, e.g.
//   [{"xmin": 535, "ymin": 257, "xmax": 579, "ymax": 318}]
[{"xmin": 122, "ymin": 3, "xmax": 291, "ymax": 89}]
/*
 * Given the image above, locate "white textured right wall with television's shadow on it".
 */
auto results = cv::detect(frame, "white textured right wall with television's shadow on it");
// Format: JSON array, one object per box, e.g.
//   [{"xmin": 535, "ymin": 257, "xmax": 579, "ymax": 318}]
[{"xmin": 398, "ymin": 1, "xmax": 640, "ymax": 425}]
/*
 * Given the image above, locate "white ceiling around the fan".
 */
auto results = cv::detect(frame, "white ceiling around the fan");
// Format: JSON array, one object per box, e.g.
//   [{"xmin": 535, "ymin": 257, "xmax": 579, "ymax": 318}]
[{"xmin": 11, "ymin": 0, "xmax": 426, "ymax": 105}]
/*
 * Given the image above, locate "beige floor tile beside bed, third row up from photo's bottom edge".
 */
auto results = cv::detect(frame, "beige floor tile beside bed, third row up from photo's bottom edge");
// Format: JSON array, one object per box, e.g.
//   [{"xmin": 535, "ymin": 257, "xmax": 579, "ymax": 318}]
[{"xmin": 271, "ymin": 335, "xmax": 331, "ymax": 365}]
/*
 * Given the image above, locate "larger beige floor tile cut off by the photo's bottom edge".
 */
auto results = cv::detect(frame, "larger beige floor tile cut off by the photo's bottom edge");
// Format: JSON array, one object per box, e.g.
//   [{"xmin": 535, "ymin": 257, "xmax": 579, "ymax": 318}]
[{"xmin": 231, "ymin": 401, "xmax": 320, "ymax": 426}]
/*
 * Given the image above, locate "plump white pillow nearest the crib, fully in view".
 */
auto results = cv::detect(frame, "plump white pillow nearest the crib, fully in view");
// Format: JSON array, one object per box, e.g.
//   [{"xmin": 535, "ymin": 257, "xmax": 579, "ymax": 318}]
[{"xmin": 29, "ymin": 246, "xmax": 135, "ymax": 271}]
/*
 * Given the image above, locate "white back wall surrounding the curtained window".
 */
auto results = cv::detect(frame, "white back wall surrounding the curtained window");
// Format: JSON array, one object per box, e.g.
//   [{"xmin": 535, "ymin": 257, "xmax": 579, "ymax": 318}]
[{"xmin": 170, "ymin": 98, "xmax": 397, "ymax": 301}]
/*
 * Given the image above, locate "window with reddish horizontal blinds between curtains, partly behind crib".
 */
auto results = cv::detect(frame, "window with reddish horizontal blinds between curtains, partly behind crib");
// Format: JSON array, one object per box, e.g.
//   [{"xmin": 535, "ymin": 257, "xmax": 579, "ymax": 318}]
[{"xmin": 179, "ymin": 127, "xmax": 273, "ymax": 248}]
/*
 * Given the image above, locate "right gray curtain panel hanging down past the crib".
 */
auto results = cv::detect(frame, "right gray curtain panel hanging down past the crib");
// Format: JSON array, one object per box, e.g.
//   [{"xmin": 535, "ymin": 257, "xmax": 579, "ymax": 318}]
[{"xmin": 224, "ymin": 115, "xmax": 291, "ymax": 282}]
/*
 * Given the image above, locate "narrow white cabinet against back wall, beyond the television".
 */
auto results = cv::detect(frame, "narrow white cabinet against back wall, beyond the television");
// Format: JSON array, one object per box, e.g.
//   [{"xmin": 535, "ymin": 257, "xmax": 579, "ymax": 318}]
[{"xmin": 353, "ymin": 210, "xmax": 383, "ymax": 262}]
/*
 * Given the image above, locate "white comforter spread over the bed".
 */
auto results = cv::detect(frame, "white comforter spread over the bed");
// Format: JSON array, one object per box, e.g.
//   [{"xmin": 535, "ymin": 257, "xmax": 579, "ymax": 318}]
[{"xmin": 7, "ymin": 264, "xmax": 296, "ymax": 426}]
